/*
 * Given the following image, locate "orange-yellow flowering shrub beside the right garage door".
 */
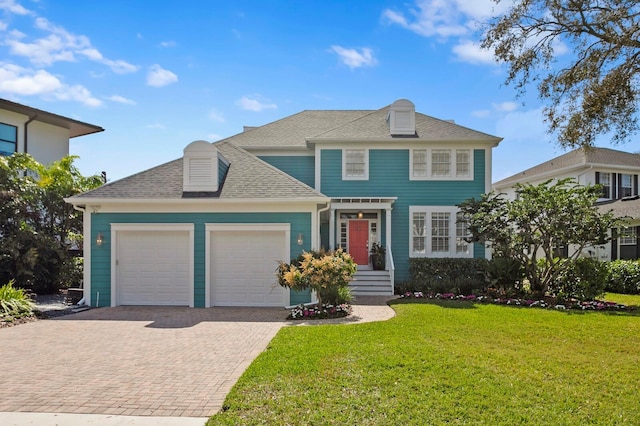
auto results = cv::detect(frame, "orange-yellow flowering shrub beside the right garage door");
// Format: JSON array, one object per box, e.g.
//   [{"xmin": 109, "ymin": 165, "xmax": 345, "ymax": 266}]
[{"xmin": 277, "ymin": 249, "xmax": 357, "ymax": 305}]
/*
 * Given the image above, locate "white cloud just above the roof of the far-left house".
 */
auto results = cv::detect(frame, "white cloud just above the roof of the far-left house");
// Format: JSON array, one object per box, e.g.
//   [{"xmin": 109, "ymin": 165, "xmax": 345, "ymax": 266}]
[{"xmin": 0, "ymin": 63, "xmax": 102, "ymax": 107}]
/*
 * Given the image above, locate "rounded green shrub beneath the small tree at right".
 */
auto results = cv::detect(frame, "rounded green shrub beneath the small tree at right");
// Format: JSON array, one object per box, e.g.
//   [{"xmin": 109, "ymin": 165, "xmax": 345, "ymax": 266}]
[{"xmin": 549, "ymin": 257, "xmax": 608, "ymax": 301}]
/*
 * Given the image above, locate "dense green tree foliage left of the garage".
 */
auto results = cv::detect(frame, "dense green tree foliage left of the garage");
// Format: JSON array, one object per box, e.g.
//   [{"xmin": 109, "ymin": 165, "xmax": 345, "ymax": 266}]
[{"xmin": 0, "ymin": 153, "xmax": 103, "ymax": 293}]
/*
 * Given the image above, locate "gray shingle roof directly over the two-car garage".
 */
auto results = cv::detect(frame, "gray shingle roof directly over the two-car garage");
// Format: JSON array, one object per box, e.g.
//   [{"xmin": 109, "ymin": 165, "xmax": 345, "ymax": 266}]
[{"xmin": 72, "ymin": 142, "xmax": 325, "ymax": 201}]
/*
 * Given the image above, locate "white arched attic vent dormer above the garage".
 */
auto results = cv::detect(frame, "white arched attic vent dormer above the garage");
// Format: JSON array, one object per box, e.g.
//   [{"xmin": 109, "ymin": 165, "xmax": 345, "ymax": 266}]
[{"xmin": 182, "ymin": 141, "xmax": 218, "ymax": 192}]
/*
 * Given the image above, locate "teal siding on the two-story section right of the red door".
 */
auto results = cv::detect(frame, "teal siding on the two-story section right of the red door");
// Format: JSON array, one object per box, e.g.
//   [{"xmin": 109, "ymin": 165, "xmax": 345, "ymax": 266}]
[{"xmin": 320, "ymin": 149, "xmax": 485, "ymax": 281}]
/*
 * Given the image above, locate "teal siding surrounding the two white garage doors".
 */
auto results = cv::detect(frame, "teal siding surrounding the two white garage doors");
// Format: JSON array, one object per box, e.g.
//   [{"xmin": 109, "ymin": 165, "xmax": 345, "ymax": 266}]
[{"xmin": 91, "ymin": 213, "xmax": 312, "ymax": 307}]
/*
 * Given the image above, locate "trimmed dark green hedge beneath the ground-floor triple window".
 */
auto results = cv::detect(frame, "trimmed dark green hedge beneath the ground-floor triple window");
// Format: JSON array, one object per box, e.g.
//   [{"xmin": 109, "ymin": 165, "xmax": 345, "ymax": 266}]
[{"xmin": 408, "ymin": 257, "xmax": 488, "ymax": 294}]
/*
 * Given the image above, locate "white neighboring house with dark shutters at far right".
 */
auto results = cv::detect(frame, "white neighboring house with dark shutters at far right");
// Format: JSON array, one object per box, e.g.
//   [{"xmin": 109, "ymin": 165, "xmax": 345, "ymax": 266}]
[{"xmin": 493, "ymin": 148, "xmax": 640, "ymax": 261}]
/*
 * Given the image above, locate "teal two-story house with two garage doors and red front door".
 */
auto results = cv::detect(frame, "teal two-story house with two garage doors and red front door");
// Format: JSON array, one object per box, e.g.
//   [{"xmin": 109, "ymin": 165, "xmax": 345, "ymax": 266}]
[{"xmin": 67, "ymin": 100, "xmax": 501, "ymax": 307}]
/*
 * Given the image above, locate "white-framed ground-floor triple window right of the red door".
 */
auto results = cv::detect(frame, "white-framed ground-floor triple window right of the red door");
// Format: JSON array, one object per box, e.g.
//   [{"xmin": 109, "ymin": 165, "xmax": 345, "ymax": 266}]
[{"xmin": 409, "ymin": 206, "xmax": 473, "ymax": 257}]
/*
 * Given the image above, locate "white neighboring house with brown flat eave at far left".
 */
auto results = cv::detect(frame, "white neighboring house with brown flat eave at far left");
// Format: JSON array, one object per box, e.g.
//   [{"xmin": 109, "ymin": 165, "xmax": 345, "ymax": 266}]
[{"xmin": 0, "ymin": 99, "xmax": 104, "ymax": 165}]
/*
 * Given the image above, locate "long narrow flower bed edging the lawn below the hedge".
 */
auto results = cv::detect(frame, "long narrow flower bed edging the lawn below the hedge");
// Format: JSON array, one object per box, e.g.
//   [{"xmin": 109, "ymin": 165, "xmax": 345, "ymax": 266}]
[{"xmin": 400, "ymin": 291, "xmax": 635, "ymax": 311}]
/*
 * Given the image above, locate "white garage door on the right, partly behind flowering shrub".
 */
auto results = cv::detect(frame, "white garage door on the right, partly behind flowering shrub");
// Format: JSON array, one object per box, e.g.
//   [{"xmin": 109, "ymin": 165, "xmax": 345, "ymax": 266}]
[{"xmin": 210, "ymin": 230, "xmax": 289, "ymax": 306}]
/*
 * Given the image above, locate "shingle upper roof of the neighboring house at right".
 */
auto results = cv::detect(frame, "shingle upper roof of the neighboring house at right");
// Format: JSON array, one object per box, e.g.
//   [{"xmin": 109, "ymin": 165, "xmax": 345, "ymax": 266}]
[{"xmin": 493, "ymin": 148, "xmax": 640, "ymax": 188}]
